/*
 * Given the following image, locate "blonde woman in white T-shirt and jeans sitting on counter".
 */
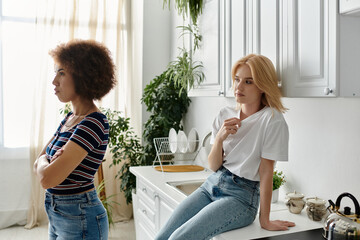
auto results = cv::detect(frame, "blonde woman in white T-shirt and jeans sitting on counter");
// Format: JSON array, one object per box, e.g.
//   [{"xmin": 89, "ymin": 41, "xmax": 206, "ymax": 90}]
[{"xmin": 156, "ymin": 54, "xmax": 295, "ymax": 240}]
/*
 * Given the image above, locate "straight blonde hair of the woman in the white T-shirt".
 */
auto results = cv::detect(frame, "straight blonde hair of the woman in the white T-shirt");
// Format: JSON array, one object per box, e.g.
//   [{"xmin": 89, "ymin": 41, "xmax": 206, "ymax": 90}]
[{"xmin": 231, "ymin": 54, "xmax": 287, "ymax": 113}]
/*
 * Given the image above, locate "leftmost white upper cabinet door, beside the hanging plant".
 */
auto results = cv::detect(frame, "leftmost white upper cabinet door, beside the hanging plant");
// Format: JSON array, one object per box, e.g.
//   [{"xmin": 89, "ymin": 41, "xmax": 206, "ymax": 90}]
[{"xmin": 189, "ymin": 0, "xmax": 224, "ymax": 96}]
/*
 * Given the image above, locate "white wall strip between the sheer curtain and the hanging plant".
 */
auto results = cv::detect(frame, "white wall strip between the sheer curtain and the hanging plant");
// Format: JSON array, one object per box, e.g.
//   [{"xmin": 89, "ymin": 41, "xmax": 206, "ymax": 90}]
[{"xmin": 138, "ymin": 0, "xmax": 173, "ymax": 135}]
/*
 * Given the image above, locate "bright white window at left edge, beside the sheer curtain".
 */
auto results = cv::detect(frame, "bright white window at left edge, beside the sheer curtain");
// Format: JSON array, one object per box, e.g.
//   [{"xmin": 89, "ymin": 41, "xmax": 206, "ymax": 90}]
[{"xmin": 0, "ymin": 0, "xmax": 36, "ymax": 152}]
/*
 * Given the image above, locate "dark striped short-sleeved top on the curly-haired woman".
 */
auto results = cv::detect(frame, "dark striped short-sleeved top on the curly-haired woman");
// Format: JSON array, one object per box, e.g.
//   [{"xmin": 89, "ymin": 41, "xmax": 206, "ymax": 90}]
[{"xmin": 46, "ymin": 112, "xmax": 109, "ymax": 195}]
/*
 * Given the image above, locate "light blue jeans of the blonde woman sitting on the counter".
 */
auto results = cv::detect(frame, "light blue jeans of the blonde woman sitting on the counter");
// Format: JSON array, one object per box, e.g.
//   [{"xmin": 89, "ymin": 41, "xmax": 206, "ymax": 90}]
[{"xmin": 155, "ymin": 167, "xmax": 260, "ymax": 240}]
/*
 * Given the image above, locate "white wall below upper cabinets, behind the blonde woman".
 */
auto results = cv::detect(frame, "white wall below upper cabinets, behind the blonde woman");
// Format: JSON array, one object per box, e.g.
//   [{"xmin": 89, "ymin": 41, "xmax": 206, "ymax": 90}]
[{"xmin": 185, "ymin": 97, "xmax": 360, "ymax": 204}]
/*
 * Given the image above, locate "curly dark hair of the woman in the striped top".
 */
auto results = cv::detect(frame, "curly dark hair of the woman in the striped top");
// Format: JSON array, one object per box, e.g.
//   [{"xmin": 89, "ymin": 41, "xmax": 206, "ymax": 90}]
[{"xmin": 49, "ymin": 40, "xmax": 116, "ymax": 100}]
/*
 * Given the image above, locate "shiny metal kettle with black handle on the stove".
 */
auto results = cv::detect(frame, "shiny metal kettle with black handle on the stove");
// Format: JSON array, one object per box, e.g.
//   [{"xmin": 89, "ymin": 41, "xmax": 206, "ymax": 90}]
[{"xmin": 323, "ymin": 193, "xmax": 360, "ymax": 240}]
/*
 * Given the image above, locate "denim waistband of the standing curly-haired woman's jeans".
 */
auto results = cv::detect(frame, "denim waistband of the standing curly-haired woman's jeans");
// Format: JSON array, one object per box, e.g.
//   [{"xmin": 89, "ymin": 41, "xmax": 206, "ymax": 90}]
[{"xmin": 45, "ymin": 189, "xmax": 98, "ymax": 203}]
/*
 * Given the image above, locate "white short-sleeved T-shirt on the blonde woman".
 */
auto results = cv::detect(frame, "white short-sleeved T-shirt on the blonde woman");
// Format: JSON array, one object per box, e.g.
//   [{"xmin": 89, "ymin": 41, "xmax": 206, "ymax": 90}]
[{"xmin": 210, "ymin": 107, "xmax": 289, "ymax": 181}]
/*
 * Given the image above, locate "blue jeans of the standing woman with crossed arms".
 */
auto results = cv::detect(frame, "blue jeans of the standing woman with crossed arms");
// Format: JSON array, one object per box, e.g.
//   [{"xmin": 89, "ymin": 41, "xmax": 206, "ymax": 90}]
[{"xmin": 45, "ymin": 190, "xmax": 109, "ymax": 240}]
